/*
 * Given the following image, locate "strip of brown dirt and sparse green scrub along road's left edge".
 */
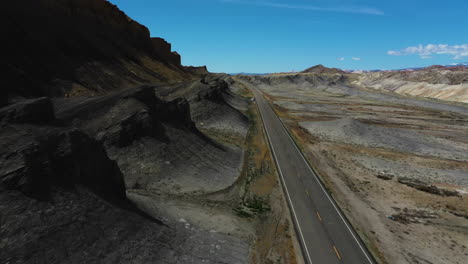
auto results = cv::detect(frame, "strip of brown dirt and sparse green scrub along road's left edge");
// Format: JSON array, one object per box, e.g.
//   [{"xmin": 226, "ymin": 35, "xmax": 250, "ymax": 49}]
[{"xmin": 227, "ymin": 88, "xmax": 300, "ymax": 264}]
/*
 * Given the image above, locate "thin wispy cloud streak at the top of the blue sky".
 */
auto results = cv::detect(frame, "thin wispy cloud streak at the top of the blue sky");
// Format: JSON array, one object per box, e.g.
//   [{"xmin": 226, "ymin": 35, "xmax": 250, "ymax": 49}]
[{"xmin": 221, "ymin": 0, "xmax": 385, "ymax": 16}]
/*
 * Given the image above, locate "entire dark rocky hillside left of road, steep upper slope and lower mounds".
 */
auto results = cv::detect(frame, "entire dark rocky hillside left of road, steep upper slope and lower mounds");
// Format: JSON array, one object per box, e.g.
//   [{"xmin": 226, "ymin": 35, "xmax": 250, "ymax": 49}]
[{"xmin": 0, "ymin": 0, "xmax": 249, "ymax": 263}]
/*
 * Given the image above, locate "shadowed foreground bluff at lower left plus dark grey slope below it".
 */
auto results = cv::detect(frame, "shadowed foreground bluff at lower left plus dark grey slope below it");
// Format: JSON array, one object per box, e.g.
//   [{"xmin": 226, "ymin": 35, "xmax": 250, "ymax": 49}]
[{"xmin": 0, "ymin": 113, "xmax": 163, "ymax": 263}]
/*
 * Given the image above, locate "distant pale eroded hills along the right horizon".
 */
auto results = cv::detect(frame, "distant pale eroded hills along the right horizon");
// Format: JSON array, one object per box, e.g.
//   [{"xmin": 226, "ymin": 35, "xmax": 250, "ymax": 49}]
[{"xmin": 264, "ymin": 65, "xmax": 468, "ymax": 103}]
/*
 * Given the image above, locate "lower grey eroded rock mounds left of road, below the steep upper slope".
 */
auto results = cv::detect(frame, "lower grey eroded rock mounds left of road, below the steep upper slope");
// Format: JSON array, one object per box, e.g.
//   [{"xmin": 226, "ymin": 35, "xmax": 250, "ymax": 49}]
[{"xmin": 0, "ymin": 76, "xmax": 252, "ymax": 263}]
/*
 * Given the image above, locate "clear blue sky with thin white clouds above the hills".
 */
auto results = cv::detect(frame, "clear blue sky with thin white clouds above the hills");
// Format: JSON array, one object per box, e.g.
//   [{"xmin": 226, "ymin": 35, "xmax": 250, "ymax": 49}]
[{"xmin": 110, "ymin": 0, "xmax": 468, "ymax": 73}]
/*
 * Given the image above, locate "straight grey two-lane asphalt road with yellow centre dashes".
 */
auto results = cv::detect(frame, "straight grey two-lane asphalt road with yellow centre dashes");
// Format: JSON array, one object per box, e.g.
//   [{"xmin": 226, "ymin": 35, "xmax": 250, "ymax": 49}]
[{"xmin": 252, "ymin": 85, "xmax": 374, "ymax": 264}]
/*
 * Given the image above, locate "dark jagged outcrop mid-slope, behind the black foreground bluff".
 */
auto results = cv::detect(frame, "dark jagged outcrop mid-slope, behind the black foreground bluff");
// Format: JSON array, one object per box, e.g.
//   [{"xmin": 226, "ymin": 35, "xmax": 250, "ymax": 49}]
[{"xmin": 89, "ymin": 86, "xmax": 196, "ymax": 147}]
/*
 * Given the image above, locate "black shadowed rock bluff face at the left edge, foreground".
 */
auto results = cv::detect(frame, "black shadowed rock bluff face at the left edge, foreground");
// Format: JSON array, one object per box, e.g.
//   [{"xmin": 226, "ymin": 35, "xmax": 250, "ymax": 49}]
[{"xmin": 0, "ymin": 125, "xmax": 125, "ymax": 199}]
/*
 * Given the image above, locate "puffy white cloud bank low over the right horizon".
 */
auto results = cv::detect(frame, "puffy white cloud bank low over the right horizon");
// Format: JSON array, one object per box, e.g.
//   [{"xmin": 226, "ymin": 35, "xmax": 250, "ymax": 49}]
[{"xmin": 387, "ymin": 44, "xmax": 468, "ymax": 60}]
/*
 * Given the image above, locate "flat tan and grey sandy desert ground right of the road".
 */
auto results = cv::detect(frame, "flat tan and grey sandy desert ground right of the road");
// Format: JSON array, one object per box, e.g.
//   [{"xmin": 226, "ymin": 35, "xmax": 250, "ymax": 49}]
[{"xmin": 238, "ymin": 73, "xmax": 468, "ymax": 264}]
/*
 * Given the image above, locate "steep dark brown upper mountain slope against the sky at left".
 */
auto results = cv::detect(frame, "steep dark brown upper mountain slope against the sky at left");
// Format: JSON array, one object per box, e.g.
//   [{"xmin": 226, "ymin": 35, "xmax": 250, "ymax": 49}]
[{"xmin": 0, "ymin": 0, "xmax": 206, "ymax": 106}]
